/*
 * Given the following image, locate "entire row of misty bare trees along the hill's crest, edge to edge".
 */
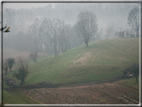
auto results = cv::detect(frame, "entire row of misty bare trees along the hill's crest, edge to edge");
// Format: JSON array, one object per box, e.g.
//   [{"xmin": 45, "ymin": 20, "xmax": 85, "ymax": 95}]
[{"xmin": 4, "ymin": 7, "xmax": 139, "ymax": 56}]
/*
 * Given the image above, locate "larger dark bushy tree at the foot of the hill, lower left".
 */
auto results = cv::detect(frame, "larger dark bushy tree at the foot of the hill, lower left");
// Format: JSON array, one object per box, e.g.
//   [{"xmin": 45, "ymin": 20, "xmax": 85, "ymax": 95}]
[{"xmin": 13, "ymin": 59, "xmax": 29, "ymax": 85}]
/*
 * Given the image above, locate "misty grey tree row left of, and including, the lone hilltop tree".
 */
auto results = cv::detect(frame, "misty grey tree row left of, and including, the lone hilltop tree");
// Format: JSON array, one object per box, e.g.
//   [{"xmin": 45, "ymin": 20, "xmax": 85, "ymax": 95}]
[{"xmin": 4, "ymin": 11, "xmax": 98, "ymax": 56}]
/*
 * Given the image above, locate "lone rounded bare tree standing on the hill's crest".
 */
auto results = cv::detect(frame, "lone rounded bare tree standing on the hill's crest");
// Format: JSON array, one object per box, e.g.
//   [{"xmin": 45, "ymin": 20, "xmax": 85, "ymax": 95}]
[{"xmin": 76, "ymin": 11, "xmax": 98, "ymax": 47}]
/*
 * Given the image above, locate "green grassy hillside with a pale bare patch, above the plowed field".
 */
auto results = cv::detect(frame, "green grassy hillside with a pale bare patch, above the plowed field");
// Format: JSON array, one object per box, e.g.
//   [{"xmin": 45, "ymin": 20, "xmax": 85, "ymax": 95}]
[{"xmin": 4, "ymin": 38, "xmax": 139, "ymax": 85}]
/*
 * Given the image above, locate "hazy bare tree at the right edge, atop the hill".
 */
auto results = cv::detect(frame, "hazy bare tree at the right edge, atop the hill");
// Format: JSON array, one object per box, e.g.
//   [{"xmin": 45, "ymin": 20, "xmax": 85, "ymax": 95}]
[{"xmin": 128, "ymin": 7, "xmax": 139, "ymax": 37}]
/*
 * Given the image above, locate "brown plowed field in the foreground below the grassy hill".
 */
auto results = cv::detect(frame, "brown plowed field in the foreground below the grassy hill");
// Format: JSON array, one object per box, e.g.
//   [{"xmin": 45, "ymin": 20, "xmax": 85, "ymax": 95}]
[{"xmin": 20, "ymin": 82, "xmax": 139, "ymax": 104}]
